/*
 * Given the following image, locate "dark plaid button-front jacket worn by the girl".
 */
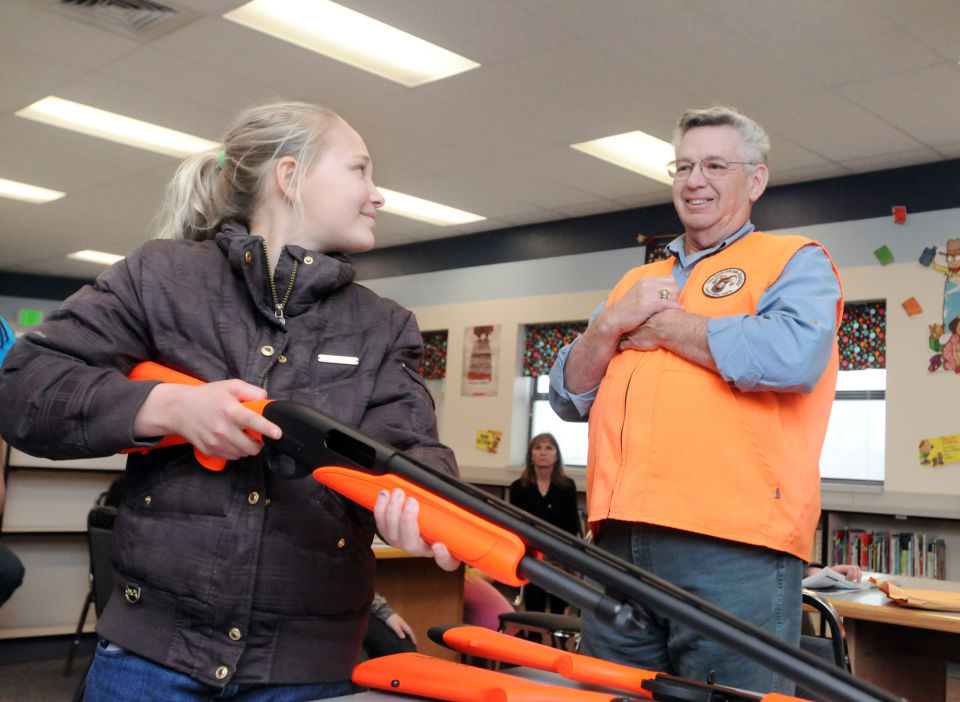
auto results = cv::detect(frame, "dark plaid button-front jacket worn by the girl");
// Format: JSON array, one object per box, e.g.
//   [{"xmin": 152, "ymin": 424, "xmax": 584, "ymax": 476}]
[{"xmin": 0, "ymin": 225, "xmax": 457, "ymax": 685}]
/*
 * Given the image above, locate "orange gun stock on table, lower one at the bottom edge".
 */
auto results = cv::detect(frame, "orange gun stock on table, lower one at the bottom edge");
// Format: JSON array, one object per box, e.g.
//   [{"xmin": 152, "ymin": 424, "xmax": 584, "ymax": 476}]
[{"xmin": 353, "ymin": 653, "xmax": 623, "ymax": 702}]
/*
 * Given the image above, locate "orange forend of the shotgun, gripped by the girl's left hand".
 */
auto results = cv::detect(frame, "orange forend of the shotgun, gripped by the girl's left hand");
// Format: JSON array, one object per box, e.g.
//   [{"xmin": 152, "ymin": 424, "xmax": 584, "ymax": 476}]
[{"xmin": 313, "ymin": 466, "xmax": 528, "ymax": 587}]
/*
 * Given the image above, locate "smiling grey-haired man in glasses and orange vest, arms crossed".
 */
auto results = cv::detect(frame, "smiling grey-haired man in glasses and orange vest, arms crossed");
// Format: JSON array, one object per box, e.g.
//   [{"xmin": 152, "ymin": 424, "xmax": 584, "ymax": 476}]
[{"xmin": 550, "ymin": 107, "xmax": 843, "ymax": 692}]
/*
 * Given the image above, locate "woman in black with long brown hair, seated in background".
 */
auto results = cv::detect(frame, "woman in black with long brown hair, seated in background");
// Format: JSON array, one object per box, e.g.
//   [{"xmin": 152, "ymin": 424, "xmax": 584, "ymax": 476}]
[{"xmin": 510, "ymin": 434, "xmax": 580, "ymax": 614}]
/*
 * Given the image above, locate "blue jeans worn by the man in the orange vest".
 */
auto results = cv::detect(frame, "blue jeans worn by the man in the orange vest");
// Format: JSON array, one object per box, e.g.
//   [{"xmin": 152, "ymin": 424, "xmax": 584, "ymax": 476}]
[{"xmin": 581, "ymin": 520, "xmax": 804, "ymax": 695}]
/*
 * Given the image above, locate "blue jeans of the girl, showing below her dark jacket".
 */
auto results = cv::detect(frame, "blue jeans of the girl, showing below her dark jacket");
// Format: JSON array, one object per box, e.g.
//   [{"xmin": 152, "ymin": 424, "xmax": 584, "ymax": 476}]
[{"xmin": 83, "ymin": 639, "xmax": 354, "ymax": 702}]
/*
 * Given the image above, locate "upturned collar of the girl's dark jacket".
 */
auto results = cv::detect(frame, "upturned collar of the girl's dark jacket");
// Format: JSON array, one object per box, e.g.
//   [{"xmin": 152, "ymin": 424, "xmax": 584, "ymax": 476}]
[{"xmin": 216, "ymin": 223, "xmax": 356, "ymax": 317}]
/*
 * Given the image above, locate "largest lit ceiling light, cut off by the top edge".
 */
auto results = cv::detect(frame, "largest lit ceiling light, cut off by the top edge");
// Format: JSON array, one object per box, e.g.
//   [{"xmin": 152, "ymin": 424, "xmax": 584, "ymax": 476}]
[{"xmin": 224, "ymin": 0, "xmax": 480, "ymax": 88}]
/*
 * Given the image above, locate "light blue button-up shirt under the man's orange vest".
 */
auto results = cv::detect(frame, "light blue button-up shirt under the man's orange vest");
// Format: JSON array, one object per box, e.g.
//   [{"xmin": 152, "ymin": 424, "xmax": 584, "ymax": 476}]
[{"xmin": 550, "ymin": 220, "xmax": 840, "ymax": 421}]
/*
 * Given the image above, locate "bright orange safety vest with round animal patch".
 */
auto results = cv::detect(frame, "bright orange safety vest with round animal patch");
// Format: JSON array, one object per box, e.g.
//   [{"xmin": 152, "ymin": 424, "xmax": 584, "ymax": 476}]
[{"xmin": 587, "ymin": 232, "xmax": 843, "ymax": 560}]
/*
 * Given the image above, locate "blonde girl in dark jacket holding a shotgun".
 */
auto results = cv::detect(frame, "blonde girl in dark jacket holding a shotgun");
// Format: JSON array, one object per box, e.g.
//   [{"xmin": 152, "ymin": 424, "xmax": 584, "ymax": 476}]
[{"xmin": 0, "ymin": 103, "xmax": 457, "ymax": 701}]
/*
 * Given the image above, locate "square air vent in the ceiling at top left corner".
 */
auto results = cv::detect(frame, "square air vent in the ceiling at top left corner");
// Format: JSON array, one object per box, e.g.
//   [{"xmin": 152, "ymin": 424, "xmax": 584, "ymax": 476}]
[{"xmin": 54, "ymin": 0, "xmax": 200, "ymax": 40}]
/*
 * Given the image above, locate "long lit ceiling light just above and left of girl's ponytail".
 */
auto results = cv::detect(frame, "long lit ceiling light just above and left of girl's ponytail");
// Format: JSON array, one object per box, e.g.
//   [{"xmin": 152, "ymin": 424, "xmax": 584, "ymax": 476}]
[{"xmin": 16, "ymin": 95, "xmax": 220, "ymax": 158}]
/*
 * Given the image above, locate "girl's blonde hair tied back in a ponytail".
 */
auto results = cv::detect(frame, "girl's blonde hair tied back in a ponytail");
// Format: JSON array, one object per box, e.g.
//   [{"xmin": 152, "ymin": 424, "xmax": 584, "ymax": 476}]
[{"xmin": 155, "ymin": 102, "xmax": 343, "ymax": 241}]
